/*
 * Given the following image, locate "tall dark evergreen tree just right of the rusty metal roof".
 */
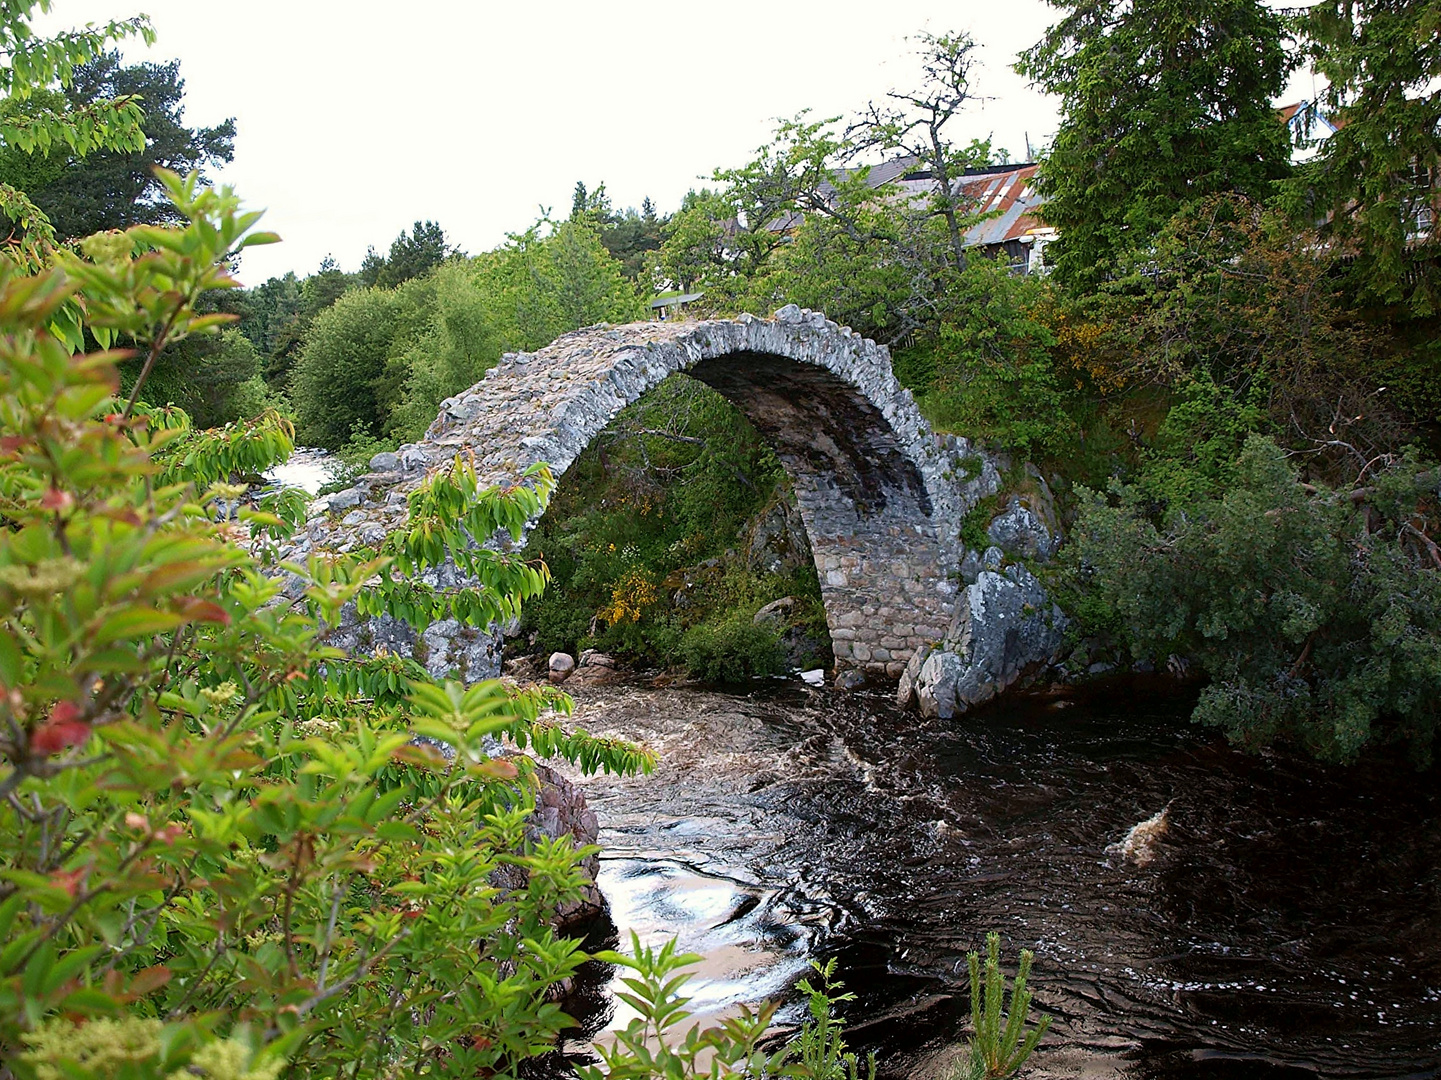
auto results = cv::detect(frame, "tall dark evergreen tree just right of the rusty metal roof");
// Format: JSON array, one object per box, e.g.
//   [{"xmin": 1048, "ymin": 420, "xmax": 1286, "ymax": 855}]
[{"xmin": 1016, "ymin": 0, "xmax": 1294, "ymax": 288}]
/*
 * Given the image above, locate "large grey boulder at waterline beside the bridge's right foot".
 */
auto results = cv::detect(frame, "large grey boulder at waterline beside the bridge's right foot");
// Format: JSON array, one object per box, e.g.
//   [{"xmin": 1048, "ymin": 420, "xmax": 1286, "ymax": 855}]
[{"xmin": 896, "ymin": 565, "xmax": 1066, "ymax": 718}]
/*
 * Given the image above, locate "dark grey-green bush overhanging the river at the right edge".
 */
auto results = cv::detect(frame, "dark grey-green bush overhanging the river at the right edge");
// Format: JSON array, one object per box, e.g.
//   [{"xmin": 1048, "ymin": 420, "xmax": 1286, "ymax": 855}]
[{"xmin": 1071, "ymin": 435, "xmax": 1441, "ymax": 760}]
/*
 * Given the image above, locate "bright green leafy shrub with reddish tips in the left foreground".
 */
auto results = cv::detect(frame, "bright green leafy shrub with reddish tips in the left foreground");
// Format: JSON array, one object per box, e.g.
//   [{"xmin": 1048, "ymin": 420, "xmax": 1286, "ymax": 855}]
[{"xmin": 0, "ymin": 164, "xmax": 703, "ymax": 1080}]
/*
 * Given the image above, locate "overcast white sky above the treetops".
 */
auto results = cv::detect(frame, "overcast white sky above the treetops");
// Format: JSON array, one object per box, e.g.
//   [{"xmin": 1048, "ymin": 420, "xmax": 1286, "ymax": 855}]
[{"xmin": 42, "ymin": 0, "xmax": 1319, "ymax": 284}]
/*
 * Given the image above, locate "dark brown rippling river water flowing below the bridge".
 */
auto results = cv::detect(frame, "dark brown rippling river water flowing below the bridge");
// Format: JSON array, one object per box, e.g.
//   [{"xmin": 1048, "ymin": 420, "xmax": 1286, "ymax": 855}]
[{"xmin": 547, "ymin": 685, "xmax": 1441, "ymax": 1080}]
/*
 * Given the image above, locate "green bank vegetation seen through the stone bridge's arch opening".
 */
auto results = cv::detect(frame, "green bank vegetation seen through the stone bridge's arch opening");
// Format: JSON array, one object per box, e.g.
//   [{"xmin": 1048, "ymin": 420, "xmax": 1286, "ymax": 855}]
[{"xmin": 517, "ymin": 372, "xmax": 834, "ymax": 681}]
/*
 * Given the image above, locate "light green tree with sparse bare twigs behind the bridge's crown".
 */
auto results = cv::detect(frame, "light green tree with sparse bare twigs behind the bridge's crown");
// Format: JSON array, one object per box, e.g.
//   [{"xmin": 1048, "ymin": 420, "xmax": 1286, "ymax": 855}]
[{"xmin": 659, "ymin": 95, "xmax": 990, "ymax": 342}]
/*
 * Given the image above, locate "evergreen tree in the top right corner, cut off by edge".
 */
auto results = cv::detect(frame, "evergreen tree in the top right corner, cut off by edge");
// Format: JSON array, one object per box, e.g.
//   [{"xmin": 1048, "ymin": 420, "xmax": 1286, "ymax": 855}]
[{"xmin": 1288, "ymin": 0, "xmax": 1441, "ymax": 316}]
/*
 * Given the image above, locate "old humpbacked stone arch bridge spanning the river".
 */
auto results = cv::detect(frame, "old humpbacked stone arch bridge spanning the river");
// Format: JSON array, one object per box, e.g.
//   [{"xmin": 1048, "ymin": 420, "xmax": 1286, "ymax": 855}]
[{"xmin": 301, "ymin": 306, "xmax": 1066, "ymax": 706}]
